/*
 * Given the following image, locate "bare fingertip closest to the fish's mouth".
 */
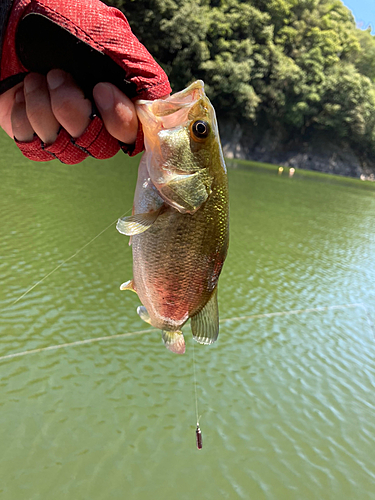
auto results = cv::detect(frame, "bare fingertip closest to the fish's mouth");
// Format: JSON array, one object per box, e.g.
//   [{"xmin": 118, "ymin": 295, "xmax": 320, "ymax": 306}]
[{"xmin": 93, "ymin": 83, "xmax": 138, "ymax": 144}]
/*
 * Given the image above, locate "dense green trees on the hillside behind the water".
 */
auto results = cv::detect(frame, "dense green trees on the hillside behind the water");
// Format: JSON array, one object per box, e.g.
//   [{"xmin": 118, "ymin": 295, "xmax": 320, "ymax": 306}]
[{"xmin": 107, "ymin": 0, "xmax": 375, "ymax": 155}]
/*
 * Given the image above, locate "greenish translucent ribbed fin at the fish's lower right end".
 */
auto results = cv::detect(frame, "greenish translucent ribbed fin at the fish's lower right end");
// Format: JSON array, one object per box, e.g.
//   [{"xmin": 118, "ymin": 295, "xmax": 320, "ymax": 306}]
[{"xmin": 191, "ymin": 287, "xmax": 219, "ymax": 344}]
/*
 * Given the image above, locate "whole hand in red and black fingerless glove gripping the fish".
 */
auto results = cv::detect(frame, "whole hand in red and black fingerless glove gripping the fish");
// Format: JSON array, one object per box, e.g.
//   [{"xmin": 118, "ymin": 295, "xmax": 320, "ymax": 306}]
[{"xmin": 0, "ymin": 0, "xmax": 171, "ymax": 164}]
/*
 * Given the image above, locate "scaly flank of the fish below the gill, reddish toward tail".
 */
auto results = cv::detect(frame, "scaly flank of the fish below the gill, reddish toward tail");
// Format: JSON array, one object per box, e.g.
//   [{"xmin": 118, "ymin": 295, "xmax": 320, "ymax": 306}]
[{"xmin": 132, "ymin": 207, "xmax": 226, "ymax": 330}]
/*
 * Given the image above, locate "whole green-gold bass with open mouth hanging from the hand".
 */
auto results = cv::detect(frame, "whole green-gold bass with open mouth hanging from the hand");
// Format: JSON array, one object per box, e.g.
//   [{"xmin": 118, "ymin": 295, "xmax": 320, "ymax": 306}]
[{"xmin": 116, "ymin": 80, "xmax": 229, "ymax": 354}]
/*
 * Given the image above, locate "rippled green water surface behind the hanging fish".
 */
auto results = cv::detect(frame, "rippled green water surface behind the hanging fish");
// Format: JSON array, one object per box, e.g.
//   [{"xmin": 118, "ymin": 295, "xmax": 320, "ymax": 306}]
[{"xmin": 0, "ymin": 135, "xmax": 375, "ymax": 500}]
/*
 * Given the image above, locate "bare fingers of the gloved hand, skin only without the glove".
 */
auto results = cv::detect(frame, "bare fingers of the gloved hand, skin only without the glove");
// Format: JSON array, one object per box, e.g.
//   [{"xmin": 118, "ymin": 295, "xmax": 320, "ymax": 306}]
[{"xmin": 0, "ymin": 69, "xmax": 138, "ymax": 145}]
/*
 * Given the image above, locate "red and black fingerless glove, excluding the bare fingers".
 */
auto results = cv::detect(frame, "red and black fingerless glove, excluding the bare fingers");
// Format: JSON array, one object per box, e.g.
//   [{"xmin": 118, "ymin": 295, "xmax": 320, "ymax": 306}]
[{"xmin": 0, "ymin": 0, "xmax": 171, "ymax": 163}]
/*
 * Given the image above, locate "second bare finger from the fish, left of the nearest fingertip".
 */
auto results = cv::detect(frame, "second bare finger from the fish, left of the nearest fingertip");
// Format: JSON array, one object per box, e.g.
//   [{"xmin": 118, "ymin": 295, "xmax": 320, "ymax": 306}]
[{"xmin": 47, "ymin": 69, "xmax": 92, "ymax": 138}]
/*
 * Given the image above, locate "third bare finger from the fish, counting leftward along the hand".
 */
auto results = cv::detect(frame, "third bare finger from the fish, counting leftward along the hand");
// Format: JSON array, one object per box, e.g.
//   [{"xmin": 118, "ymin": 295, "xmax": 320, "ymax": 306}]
[{"xmin": 24, "ymin": 73, "xmax": 60, "ymax": 144}]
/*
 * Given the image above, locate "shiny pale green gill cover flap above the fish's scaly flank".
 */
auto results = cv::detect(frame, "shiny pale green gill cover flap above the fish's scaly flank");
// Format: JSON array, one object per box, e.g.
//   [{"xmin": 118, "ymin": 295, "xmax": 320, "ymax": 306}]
[{"xmin": 159, "ymin": 172, "xmax": 211, "ymax": 213}]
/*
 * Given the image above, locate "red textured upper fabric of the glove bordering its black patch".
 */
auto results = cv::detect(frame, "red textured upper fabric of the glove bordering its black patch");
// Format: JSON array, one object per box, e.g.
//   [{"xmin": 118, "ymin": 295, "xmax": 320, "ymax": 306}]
[{"xmin": 0, "ymin": 0, "xmax": 171, "ymax": 99}]
